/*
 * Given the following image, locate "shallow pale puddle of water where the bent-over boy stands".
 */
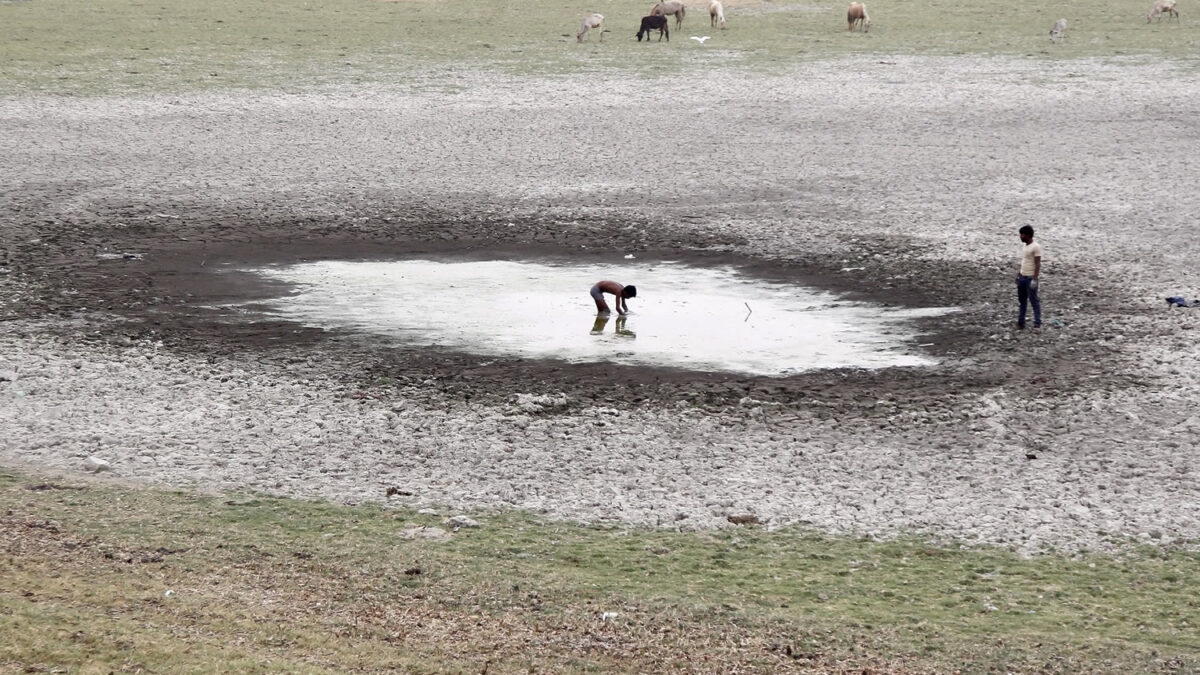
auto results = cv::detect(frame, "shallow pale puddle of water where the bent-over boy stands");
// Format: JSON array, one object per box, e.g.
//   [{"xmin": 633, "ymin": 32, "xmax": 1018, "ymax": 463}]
[{"xmin": 257, "ymin": 261, "xmax": 950, "ymax": 376}]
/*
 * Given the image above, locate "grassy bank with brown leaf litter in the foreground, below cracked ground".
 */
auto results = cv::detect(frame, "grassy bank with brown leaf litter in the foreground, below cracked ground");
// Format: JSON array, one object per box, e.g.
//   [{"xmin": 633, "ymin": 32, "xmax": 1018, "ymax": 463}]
[{"xmin": 0, "ymin": 471, "xmax": 1200, "ymax": 673}]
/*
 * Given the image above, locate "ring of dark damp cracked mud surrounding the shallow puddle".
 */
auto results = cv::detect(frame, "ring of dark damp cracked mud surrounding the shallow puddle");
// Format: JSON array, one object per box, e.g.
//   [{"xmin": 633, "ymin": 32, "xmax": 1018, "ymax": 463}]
[{"xmin": 0, "ymin": 199, "xmax": 1116, "ymax": 417}]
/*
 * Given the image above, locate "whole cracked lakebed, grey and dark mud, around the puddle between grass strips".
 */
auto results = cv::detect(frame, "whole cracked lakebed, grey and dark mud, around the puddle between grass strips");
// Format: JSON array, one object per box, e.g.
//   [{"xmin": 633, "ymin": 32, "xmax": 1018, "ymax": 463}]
[{"xmin": 0, "ymin": 56, "xmax": 1200, "ymax": 551}]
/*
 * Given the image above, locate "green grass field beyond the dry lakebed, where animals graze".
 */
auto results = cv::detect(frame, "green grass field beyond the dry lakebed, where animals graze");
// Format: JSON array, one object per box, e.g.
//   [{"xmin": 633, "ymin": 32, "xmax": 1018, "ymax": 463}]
[{"xmin": 0, "ymin": 0, "xmax": 1200, "ymax": 95}]
